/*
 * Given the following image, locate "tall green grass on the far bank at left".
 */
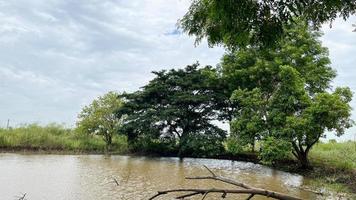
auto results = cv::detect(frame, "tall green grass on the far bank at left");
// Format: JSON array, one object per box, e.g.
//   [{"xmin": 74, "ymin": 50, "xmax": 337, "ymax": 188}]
[{"xmin": 0, "ymin": 124, "xmax": 127, "ymax": 153}]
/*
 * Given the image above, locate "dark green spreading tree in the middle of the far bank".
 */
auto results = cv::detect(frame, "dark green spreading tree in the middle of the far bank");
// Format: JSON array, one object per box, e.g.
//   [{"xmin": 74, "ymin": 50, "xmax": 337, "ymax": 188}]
[{"xmin": 119, "ymin": 64, "xmax": 225, "ymax": 156}]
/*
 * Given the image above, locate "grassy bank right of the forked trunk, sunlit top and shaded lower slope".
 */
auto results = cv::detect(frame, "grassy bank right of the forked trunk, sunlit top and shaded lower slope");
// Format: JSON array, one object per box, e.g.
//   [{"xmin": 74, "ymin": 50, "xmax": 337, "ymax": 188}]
[{"xmin": 301, "ymin": 141, "xmax": 356, "ymax": 195}]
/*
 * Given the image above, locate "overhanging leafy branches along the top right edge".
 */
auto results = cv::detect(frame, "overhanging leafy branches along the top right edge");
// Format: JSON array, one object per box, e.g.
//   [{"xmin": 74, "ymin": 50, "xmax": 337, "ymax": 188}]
[{"xmin": 179, "ymin": 0, "xmax": 356, "ymax": 49}]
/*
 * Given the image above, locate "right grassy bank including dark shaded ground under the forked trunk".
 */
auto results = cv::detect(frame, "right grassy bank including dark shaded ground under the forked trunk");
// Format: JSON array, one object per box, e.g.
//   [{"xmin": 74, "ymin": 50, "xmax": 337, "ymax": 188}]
[{"xmin": 264, "ymin": 141, "xmax": 356, "ymax": 199}]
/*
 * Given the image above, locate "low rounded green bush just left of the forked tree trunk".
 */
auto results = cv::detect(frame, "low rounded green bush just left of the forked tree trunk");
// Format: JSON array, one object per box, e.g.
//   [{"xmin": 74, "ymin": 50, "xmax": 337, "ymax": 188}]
[{"xmin": 259, "ymin": 137, "xmax": 292, "ymax": 164}]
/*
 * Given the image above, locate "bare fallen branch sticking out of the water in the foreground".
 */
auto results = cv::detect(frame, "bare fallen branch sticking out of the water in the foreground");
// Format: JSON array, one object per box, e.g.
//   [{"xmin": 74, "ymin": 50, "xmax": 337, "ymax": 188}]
[{"xmin": 149, "ymin": 165, "xmax": 300, "ymax": 200}]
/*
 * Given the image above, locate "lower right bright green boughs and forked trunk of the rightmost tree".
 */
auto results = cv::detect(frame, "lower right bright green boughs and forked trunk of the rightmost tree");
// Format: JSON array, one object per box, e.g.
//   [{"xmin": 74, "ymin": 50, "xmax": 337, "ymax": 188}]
[{"xmin": 283, "ymin": 88, "xmax": 353, "ymax": 168}]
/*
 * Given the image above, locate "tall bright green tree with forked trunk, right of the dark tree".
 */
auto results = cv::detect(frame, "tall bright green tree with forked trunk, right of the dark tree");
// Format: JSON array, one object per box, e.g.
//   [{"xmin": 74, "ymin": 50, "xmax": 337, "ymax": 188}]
[{"xmin": 221, "ymin": 21, "xmax": 352, "ymax": 167}]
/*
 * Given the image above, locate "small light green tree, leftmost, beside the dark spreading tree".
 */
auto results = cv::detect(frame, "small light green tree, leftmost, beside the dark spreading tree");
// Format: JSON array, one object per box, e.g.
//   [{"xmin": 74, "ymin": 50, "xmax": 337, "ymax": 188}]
[{"xmin": 77, "ymin": 91, "xmax": 123, "ymax": 150}]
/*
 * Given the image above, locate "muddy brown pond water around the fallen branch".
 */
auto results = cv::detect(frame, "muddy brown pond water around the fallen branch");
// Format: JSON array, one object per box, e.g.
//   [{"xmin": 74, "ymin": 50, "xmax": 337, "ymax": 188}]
[{"xmin": 0, "ymin": 153, "xmax": 316, "ymax": 200}]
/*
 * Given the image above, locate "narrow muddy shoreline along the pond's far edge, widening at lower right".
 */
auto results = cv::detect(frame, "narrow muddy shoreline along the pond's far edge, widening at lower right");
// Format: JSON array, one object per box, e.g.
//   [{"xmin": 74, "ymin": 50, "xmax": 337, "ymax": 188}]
[{"xmin": 0, "ymin": 148, "xmax": 356, "ymax": 198}]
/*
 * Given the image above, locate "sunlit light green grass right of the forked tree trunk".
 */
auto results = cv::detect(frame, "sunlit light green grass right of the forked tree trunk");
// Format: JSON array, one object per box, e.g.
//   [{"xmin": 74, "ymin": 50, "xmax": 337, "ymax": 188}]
[{"xmin": 310, "ymin": 141, "xmax": 356, "ymax": 170}]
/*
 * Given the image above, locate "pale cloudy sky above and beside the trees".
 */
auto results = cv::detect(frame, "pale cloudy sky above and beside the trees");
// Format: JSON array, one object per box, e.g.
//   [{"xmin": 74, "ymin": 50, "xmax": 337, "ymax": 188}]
[{"xmin": 0, "ymin": 0, "xmax": 356, "ymax": 140}]
